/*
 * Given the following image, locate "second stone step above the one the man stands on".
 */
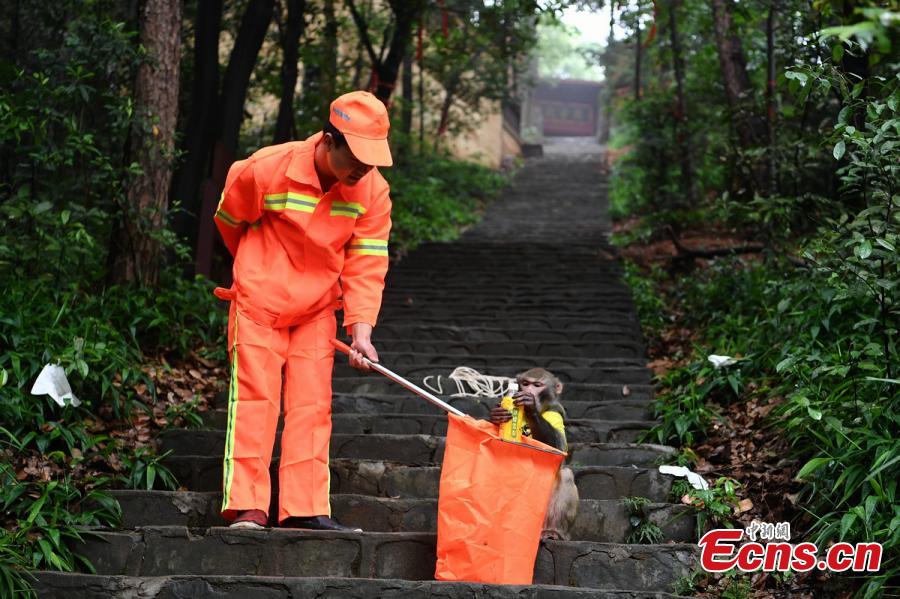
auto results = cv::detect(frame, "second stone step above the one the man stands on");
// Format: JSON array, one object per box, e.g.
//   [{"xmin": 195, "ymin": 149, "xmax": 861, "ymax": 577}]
[{"xmin": 165, "ymin": 455, "xmax": 672, "ymax": 503}]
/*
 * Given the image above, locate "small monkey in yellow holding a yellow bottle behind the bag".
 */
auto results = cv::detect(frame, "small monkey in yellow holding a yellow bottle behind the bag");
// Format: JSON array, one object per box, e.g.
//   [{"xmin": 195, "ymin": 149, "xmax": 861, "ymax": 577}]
[{"xmin": 491, "ymin": 368, "xmax": 578, "ymax": 541}]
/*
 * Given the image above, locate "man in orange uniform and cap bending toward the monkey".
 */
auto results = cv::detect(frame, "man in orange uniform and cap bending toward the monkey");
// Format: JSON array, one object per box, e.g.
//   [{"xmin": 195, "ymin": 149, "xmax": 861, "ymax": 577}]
[{"xmin": 215, "ymin": 92, "xmax": 392, "ymax": 530}]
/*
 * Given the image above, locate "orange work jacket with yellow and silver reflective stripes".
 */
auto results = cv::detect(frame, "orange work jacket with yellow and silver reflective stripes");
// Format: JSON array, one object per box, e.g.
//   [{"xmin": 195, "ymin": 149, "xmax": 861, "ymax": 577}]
[{"xmin": 215, "ymin": 133, "xmax": 391, "ymax": 328}]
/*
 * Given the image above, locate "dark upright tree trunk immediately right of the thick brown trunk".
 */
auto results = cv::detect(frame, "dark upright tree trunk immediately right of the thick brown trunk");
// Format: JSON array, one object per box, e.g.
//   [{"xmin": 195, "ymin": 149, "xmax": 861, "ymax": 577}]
[{"xmin": 171, "ymin": 0, "xmax": 222, "ymax": 252}]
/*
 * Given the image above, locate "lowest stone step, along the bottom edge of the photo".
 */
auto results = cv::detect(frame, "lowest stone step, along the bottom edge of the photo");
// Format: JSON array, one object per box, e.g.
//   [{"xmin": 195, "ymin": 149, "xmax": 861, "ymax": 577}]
[{"xmin": 33, "ymin": 572, "xmax": 679, "ymax": 599}]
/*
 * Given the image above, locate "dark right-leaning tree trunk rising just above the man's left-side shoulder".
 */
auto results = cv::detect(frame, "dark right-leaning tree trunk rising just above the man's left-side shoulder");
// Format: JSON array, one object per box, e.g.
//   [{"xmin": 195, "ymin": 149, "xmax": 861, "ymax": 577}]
[{"xmin": 219, "ymin": 0, "xmax": 275, "ymax": 156}]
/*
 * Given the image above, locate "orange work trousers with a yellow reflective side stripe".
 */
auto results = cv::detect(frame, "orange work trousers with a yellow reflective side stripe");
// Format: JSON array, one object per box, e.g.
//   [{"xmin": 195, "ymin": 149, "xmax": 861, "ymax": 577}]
[{"xmin": 222, "ymin": 302, "xmax": 337, "ymax": 522}]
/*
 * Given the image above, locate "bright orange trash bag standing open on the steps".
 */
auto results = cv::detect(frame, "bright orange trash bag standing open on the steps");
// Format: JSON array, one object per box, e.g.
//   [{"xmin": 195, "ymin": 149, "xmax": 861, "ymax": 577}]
[{"xmin": 434, "ymin": 414, "xmax": 565, "ymax": 584}]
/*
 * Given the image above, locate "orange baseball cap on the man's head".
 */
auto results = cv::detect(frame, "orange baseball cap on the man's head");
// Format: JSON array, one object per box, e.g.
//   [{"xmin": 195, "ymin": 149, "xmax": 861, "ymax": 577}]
[{"xmin": 328, "ymin": 92, "xmax": 394, "ymax": 166}]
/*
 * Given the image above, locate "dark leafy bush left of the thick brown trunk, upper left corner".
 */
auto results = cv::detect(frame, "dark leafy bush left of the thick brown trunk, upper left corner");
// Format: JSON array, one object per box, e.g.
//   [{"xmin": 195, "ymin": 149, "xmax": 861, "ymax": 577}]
[{"xmin": 0, "ymin": 0, "xmax": 141, "ymax": 285}]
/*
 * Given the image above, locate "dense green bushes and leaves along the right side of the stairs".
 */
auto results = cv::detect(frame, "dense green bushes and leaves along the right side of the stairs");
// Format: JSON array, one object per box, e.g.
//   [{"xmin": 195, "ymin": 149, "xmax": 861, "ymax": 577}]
[{"xmin": 611, "ymin": 3, "xmax": 900, "ymax": 596}]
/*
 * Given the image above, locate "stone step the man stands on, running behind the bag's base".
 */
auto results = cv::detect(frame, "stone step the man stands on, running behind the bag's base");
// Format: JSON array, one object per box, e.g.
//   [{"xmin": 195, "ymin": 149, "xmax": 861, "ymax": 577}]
[{"xmin": 73, "ymin": 526, "xmax": 697, "ymax": 591}]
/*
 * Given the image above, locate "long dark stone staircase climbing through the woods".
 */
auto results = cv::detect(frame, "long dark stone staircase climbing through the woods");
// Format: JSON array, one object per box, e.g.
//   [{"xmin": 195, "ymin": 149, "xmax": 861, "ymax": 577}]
[{"xmin": 36, "ymin": 144, "xmax": 696, "ymax": 599}]
